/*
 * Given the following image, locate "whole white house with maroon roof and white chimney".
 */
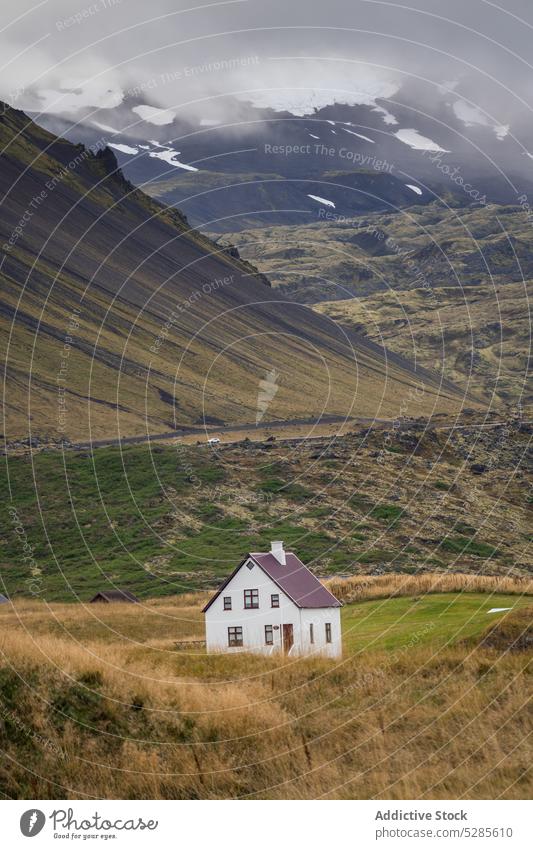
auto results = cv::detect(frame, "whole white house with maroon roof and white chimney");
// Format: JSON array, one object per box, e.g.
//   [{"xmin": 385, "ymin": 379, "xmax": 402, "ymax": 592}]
[{"xmin": 203, "ymin": 542, "xmax": 342, "ymax": 657}]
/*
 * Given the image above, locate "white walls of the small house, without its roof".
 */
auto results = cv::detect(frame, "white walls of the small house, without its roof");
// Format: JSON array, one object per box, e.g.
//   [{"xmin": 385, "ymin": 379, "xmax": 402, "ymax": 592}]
[{"xmin": 205, "ymin": 561, "xmax": 341, "ymax": 657}]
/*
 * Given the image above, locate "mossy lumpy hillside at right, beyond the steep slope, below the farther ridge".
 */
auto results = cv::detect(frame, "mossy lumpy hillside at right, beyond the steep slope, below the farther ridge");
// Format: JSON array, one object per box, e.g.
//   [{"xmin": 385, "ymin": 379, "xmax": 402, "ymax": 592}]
[{"xmin": 316, "ymin": 280, "xmax": 533, "ymax": 406}]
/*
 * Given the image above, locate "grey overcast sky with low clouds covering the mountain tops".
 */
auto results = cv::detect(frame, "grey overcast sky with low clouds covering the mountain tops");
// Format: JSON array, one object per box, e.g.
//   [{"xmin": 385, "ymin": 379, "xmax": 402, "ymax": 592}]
[{"xmin": 0, "ymin": 0, "xmax": 533, "ymax": 124}]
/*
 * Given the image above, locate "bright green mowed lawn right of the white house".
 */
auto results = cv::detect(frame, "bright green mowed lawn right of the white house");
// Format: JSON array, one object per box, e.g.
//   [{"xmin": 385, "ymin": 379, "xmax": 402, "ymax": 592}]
[{"xmin": 342, "ymin": 593, "xmax": 533, "ymax": 654}]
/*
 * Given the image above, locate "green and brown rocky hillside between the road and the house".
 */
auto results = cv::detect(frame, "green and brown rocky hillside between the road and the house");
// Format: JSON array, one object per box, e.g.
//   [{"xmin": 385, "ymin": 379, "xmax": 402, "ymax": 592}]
[{"xmin": 0, "ymin": 420, "xmax": 532, "ymax": 600}]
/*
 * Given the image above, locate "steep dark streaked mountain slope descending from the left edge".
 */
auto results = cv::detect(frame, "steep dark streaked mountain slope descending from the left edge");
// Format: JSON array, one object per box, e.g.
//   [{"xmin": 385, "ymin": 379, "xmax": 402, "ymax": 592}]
[{"xmin": 0, "ymin": 102, "xmax": 461, "ymax": 439}]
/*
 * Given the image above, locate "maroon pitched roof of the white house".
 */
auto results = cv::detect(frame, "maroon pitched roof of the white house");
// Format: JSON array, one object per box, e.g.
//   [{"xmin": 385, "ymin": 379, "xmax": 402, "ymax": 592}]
[{"xmin": 203, "ymin": 551, "xmax": 342, "ymax": 613}]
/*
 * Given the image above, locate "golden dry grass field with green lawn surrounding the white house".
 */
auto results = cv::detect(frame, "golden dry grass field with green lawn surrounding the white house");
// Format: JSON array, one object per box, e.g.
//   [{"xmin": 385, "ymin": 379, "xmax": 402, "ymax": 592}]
[{"xmin": 0, "ymin": 593, "xmax": 532, "ymax": 799}]
